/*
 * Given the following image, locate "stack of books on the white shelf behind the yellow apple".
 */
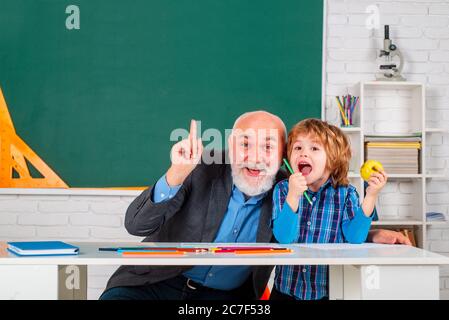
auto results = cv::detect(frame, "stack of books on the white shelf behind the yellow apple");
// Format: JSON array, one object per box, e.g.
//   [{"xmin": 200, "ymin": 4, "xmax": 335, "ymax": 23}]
[{"xmin": 365, "ymin": 135, "xmax": 421, "ymax": 174}]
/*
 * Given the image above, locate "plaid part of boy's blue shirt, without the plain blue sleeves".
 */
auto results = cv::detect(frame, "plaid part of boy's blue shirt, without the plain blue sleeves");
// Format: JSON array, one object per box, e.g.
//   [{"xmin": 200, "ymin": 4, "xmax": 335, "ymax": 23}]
[{"xmin": 273, "ymin": 179, "xmax": 363, "ymax": 300}]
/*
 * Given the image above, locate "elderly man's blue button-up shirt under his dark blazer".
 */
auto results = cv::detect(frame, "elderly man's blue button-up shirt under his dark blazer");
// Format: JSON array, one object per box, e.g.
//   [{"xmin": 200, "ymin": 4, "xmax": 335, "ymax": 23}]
[{"xmin": 153, "ymin": 175, "xmax": 266, "ymax": 290}]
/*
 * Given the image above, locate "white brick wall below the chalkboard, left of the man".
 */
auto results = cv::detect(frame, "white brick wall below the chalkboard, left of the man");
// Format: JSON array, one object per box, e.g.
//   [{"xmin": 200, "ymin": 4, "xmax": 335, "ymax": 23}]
[{"xmin": 0, "ymin": 194, "xmax": 142, "ymax": 300}]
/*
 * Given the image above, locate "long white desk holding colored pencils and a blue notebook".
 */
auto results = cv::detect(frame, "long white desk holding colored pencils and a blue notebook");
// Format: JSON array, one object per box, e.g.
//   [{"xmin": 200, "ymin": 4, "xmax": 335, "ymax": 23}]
[{"xmin": 0, "ymin": 242, "xmax": 449, "ymax": 299}]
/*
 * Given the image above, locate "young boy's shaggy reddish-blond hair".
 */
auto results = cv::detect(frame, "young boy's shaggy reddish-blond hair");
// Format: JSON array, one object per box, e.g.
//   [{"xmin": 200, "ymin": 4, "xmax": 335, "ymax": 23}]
[{"xmin": 287, "ymin": 119, "xmax": 351, "ymax": 188}]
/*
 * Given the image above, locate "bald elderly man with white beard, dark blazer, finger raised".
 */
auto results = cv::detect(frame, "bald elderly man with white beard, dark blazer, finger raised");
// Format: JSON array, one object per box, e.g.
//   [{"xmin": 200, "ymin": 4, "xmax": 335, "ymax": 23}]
[{"xmin": 101, "ymin": 111, "xmax": 409, "ymax": 300}]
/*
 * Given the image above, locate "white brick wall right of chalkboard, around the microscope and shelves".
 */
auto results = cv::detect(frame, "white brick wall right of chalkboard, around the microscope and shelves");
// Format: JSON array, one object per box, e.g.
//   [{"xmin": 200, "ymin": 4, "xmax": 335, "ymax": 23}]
[{"xmin": 325, "ymin": 0, "xmax": 449, "ymax": 299}]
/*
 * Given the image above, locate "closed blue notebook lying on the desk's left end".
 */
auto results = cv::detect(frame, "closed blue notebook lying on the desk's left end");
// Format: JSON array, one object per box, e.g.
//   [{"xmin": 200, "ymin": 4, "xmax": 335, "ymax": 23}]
[{"xmin": 8, "ymin": 241, "xmax": 79, "ymax": 256}]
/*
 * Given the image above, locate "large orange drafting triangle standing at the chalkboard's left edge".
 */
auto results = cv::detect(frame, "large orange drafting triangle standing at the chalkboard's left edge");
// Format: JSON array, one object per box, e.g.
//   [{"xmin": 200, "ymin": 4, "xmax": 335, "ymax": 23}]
[{"xmin": 0, "ymin": 88, "xmax": 68, "ymax": 188}]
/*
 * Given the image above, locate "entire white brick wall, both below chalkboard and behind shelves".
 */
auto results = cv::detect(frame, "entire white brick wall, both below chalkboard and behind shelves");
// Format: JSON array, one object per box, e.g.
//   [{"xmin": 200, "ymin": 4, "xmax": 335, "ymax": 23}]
[{"xmin": 0, "ymin": 0, "xmax": 449, "ymax": 299}]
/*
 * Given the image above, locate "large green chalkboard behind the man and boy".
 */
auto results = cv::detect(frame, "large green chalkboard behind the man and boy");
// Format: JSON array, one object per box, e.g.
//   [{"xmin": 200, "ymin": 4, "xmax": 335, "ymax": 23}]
[{"xmin": 0, "ymin": 0, "xmax": 323, "ymax": 187}]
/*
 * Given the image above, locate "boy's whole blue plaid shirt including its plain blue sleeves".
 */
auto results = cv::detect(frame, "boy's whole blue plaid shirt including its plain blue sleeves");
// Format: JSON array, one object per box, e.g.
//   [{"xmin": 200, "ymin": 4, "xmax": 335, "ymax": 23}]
[{"xmin": 273, "ymin": 179, "xmax": 373, "ymax": 300}]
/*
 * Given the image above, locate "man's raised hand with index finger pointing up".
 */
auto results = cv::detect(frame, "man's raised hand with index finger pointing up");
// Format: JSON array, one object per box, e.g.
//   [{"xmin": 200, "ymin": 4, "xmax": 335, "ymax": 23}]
[{"xmin": 166, "ymin": 120, "xmax": 203, "ymax": 186}]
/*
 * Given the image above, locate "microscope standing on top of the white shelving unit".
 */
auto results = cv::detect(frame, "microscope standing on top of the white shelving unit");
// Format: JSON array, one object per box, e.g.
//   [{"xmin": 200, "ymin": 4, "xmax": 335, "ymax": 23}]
[{"xmin": 376, "ymin": 25, "xmax": 406, "ymax": 81}]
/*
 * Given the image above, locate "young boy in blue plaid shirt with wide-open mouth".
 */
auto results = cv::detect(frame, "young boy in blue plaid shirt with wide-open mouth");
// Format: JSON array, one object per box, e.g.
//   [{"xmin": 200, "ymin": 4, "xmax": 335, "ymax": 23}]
[{"xmin": 271, "ymin": 119, "xmax": 387, "ymax": 300}]
